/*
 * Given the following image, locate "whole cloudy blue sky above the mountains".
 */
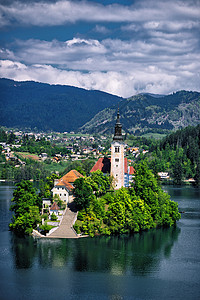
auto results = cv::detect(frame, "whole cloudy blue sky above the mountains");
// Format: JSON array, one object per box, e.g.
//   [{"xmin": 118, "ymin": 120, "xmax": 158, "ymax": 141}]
[{"xmin": 0, "ymin": 0, "xmax": 200, "ymax": 98}]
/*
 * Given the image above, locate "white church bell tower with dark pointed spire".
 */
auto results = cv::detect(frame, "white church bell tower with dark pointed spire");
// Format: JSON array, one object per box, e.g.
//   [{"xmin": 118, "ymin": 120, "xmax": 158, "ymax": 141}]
[{"xmin": 110, "ymin": 108, "xmax": 124, "ymax": 190}]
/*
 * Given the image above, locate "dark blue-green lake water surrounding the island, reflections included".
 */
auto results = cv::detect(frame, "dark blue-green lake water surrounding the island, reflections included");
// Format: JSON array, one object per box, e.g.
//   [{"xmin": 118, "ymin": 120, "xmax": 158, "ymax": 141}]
[{"xmin": 0, "ymin": 183, "xmax": 200, "ymax": 300}]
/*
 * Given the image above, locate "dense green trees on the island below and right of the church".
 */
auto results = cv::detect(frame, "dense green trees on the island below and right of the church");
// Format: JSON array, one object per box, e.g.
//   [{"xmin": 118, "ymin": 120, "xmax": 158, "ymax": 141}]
[{"xmin": 74, "ymin": 161, "xmax": 180, "ymax": 236}]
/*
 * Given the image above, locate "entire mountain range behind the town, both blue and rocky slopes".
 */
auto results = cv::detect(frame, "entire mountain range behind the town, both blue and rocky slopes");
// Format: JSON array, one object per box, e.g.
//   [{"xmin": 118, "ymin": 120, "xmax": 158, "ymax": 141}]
[{"xmin": 0, "ymin": 79, "xmax": 200, "ymax": 133}]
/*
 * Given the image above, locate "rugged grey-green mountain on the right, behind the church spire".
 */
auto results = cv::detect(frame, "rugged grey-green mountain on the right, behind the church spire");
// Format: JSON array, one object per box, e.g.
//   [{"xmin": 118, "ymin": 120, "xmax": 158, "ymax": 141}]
[{"xmin": 80, "ymin": 91, "xmax": 200, "ymax": 133}]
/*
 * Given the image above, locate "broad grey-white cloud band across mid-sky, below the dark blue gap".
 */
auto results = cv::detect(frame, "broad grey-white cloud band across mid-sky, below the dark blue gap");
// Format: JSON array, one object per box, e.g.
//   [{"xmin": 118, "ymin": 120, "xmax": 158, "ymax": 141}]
[{"xmin": 0, "ymin": 32, "xmax": 200, "ymax": 72}]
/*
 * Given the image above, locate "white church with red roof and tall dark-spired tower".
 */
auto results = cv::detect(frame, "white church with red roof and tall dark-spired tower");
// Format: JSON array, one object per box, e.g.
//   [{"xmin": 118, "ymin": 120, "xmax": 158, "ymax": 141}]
[{"xmin": 90, "ymin": 109, "xmax": 134, "ymax": 190}]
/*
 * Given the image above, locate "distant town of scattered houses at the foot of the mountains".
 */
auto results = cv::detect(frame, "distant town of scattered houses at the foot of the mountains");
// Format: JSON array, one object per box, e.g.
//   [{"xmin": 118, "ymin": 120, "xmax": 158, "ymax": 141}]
[{"xmin": 0, "ymin": 130, "xmax": 148, "ymax": 175}]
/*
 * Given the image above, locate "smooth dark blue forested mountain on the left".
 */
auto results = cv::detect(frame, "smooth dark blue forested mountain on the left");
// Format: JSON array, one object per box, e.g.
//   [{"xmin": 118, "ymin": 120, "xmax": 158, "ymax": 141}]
[{"xmin": 0, "ymin": 79, "xmax": 122, "ymax": 132}]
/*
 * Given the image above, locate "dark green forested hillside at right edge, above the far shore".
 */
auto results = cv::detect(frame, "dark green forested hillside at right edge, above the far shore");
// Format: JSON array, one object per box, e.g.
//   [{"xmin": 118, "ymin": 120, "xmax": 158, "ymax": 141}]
[{"xmin": 148, "ymin": 124, "xmax": 200, "ymax": 185}]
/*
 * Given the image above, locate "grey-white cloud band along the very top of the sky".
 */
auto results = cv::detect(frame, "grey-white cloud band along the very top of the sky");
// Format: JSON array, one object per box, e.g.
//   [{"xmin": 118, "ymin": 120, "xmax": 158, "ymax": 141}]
[{"xmin": 0, "ymin": 0, "xmax": 200, "ymax": 26}]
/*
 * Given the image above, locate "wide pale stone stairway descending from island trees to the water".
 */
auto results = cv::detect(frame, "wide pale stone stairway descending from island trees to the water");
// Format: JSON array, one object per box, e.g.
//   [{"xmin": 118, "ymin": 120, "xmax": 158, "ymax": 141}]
[{"xmin": 48, "ymin": 203, "xmax": 79, "ymax": 239}]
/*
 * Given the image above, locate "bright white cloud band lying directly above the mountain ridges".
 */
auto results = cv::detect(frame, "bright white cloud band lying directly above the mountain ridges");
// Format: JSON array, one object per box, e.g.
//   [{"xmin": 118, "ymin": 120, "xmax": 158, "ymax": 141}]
[{"xmin": 0, "ymin": 60, "xmax": 200, "ymax": 97}]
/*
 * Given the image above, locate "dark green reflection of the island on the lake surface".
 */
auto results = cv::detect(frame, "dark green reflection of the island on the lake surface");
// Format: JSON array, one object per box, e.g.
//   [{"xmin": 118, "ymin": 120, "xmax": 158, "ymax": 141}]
[{"xmin": 12, "ymin": 227, "xmax": 180, "ymax": 276}]
